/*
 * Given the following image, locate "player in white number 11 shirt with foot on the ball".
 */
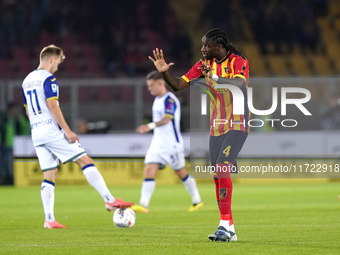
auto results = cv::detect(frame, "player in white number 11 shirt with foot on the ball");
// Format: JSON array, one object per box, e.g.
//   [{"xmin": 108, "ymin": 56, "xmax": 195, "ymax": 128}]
[{"xmin": 22, "ymin": 45, "xmax": 133, "ymax": 228}]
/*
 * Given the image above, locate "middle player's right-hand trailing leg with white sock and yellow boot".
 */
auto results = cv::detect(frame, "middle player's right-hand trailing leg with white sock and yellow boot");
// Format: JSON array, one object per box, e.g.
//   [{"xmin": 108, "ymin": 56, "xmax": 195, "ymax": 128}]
[{"xmin": 175, "ymin": 168, "xmax": 204, "ymax": 212}]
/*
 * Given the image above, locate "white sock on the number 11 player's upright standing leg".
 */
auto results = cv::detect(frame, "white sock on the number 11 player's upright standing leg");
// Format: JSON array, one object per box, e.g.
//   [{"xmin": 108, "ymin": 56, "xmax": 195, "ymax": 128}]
[{"xmin": 40, "ymin": 179, "xmax": 55, "ymax": 222}]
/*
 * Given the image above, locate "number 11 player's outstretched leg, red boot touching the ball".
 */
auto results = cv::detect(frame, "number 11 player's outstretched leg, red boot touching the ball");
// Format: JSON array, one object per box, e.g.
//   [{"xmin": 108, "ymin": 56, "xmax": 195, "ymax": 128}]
[{"xmin": 76, "ymin": 154, "xmax": 134, "ymax": 211}]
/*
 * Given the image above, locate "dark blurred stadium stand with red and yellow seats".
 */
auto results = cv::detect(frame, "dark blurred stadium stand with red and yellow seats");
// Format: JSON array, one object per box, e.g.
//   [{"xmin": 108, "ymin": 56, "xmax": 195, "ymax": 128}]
[{"xmin": 0, "ymin": 0, "xmax": 340, "ymax": 78}]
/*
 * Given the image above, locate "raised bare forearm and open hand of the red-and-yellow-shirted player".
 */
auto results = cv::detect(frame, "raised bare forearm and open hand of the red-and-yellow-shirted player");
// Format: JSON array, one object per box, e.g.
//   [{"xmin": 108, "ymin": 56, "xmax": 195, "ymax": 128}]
[{"xmin": 149, "ymin": 48, "xmax": 189, "ymax": 91}]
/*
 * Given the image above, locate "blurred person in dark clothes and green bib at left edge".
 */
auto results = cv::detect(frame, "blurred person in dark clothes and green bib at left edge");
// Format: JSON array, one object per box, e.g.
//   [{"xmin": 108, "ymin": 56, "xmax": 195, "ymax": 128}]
[{"xmin": 0, "ymin": 102, "xmax": 31, "ymax": 184}]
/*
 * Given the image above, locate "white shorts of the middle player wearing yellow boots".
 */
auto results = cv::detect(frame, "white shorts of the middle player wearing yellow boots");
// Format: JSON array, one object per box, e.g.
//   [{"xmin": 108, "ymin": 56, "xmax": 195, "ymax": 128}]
[{"xmin": 144, "ymin": 149, "xmax": 185, "ymax": 171}]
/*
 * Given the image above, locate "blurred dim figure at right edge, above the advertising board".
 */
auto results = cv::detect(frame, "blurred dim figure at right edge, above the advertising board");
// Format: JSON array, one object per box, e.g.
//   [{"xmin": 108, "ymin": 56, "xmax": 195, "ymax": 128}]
[{"xmin": 321, "ymin": 95, "xmax": 340, "ymax": 130}]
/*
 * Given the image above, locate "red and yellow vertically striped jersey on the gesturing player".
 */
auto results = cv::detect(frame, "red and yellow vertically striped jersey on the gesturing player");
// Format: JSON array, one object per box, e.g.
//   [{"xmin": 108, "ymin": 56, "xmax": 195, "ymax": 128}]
[{"xmin": 182, "ymin": 53, "xmax": 250, "ymax": 136}]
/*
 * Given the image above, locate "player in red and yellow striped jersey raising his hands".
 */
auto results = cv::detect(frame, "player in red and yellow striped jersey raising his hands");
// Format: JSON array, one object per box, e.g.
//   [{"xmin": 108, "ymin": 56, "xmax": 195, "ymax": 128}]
[{"xmin": 149, "ymin": 28, "xmax": 250, "ymax": 241}]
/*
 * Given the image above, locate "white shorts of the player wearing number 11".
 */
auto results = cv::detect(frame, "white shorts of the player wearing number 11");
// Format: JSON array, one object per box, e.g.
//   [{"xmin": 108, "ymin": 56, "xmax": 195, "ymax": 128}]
[{"xmin": 35, "ymin": 139, "xmax": 86, "ymax": 171}]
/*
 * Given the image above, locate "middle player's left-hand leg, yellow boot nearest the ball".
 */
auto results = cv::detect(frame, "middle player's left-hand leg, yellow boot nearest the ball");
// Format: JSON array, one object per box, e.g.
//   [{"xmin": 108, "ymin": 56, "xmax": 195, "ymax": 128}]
[{"xmin": 131, "ymin": 163, "xmax": 159, "ymax": 213}]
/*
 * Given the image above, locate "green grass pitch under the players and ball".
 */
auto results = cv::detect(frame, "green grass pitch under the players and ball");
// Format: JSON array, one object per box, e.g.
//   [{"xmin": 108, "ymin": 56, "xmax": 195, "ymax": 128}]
[{"xmin": 0, "ymin": 183, "xmax": 340, "ymax": 255}]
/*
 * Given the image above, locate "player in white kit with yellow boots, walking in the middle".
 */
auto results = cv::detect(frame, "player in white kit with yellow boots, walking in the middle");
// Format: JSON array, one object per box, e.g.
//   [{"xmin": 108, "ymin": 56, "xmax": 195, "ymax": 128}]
[{"xmin": 131, "ymin": 71, "xmax": 204, "ymax": 213}]
